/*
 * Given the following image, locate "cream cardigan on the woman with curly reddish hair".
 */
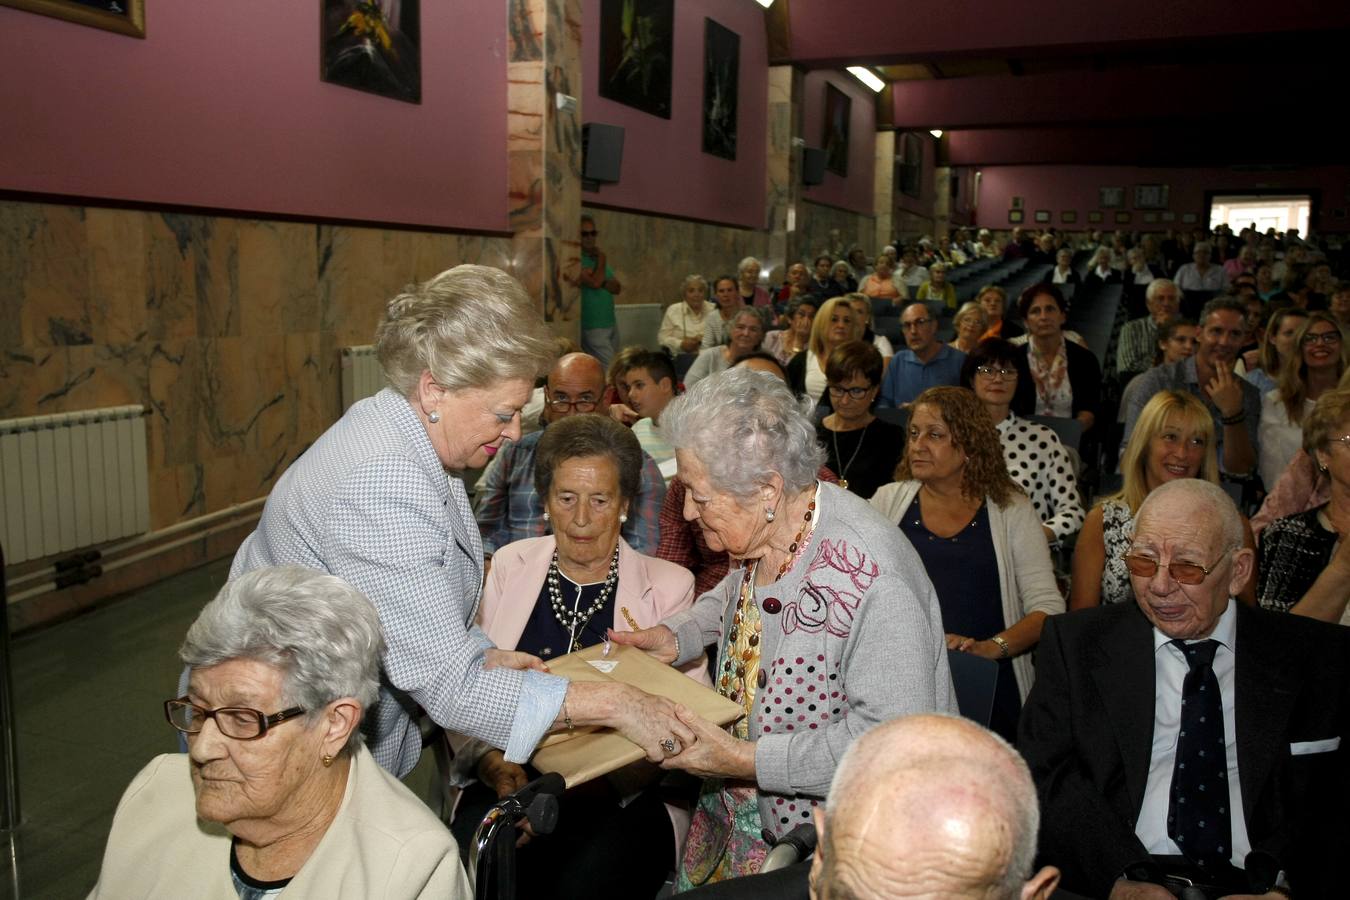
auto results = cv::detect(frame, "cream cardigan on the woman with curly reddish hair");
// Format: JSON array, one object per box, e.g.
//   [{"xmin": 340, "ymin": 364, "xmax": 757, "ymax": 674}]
[{"xmin": 871, "ymin": 480, "xmax": 1064, "ymax": 703}]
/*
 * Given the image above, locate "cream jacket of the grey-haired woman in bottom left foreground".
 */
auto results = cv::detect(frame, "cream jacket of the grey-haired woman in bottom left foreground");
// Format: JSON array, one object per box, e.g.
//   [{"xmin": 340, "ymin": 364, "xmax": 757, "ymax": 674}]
[{"xmin": 89, "ymin": 746, "xmax": 473, "ymax": 900}]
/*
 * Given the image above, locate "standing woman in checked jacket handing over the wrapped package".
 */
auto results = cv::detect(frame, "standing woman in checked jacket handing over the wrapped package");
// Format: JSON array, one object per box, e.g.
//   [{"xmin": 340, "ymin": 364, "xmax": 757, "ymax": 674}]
[{"xmin": 230, "ymin": 266, "xmax": 691, "ymax": 777}]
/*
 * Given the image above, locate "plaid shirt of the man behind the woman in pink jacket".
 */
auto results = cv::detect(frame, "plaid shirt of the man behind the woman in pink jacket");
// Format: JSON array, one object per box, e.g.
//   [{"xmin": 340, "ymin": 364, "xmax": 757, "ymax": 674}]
[{"xmin": 474, "ymin": 432, "xmax": 666, "ymax": 556}]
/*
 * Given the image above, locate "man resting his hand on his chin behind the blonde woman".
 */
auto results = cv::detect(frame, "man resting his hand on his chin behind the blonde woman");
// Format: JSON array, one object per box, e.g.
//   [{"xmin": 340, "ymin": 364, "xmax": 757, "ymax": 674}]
[{"xmin": 1125, "ymin": 297, "xmax": 1261, "ymax": 475}]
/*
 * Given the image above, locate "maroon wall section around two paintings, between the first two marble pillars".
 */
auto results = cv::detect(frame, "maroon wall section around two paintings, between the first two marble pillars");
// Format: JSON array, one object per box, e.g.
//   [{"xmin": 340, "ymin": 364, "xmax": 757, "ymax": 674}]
[{"xmin": 582, "ymin": 0, "xmax": 768, "ymax": 228}]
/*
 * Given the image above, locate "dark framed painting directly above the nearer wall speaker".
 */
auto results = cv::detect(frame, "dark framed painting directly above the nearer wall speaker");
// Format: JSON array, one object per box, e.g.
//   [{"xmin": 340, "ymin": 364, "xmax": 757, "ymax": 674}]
[{"xmin": 598, "ymin": 0, "xmax": 675, "ymax": 119}]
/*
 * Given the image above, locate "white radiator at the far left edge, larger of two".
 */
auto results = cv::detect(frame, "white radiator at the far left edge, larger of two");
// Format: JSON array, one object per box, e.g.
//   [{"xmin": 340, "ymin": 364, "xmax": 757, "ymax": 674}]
[{"xmin": 0, "ymin": 406, "xmax": 150, "ymax": 563}]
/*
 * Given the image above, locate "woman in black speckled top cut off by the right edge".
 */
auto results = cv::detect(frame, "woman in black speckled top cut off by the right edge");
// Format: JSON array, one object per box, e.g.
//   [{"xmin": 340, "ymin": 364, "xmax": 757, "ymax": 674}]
[{"xmin": 1253, "ymin": 387, "xmax": 1350, "ymax": 625}]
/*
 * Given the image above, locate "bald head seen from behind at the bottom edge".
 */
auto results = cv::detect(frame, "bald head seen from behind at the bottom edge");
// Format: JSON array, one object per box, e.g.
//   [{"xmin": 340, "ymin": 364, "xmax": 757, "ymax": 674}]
[{"xmin": 811, "ymin": 715, "xmax": 1058, "ymax": 900}]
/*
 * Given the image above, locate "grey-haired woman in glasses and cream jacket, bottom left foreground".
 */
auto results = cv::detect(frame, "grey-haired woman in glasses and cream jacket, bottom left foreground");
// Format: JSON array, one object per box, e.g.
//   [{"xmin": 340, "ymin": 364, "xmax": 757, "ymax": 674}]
[{"xmin": 89, "ymin": 565, "xmax": 473, "ymax": 900}]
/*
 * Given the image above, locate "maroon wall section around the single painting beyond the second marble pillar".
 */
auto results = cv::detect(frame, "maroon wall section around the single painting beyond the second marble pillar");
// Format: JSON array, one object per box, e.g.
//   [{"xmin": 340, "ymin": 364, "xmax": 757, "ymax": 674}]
[{"xmin": 801, "ymin": 69, "xmax": 876, "ymax": 216}]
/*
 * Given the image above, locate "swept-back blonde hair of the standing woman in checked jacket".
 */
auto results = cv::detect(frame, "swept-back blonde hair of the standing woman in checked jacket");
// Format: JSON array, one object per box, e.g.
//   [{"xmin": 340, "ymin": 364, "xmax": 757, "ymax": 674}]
[{"xmin": 375, "ymin": 264, "xmax": 556, "ymax": 398}]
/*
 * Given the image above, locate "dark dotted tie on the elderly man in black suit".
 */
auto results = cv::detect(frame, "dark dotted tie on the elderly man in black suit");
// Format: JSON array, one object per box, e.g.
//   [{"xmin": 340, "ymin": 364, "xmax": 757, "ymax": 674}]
[{"xmin": 1168, "ymin": 641, "xmax": 1233, "ymax": 868}]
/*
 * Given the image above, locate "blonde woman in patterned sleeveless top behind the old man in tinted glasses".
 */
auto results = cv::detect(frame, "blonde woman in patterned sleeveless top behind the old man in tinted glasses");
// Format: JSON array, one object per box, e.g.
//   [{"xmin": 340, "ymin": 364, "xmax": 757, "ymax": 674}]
[{"xmin": 1069, "ymin": 390, "xmax": 1256, "ymax": 610}]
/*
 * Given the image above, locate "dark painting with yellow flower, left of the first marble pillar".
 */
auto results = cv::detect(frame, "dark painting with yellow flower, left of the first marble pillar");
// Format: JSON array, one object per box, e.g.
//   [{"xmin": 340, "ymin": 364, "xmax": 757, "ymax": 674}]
[{"xmin": 319, "ymin": 0, "xmax": 421, "ymax": 103}]
